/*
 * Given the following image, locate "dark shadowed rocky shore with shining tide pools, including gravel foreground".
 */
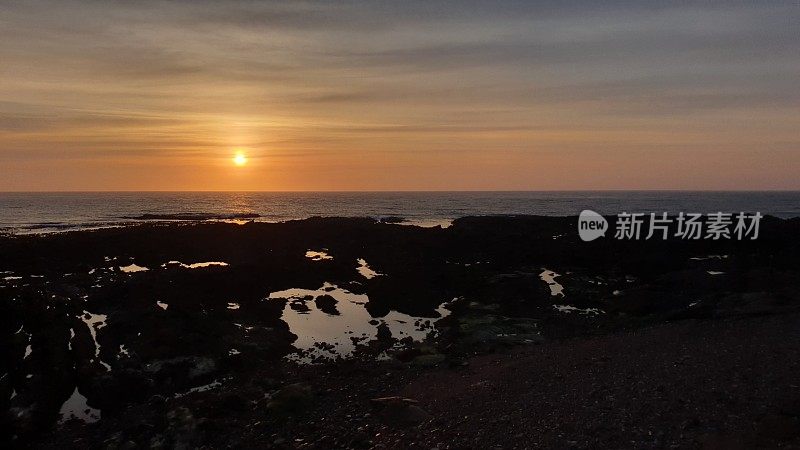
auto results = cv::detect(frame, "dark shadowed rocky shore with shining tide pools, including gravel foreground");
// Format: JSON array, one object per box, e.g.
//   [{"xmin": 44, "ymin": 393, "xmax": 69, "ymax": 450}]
[{"xmin": 0, "ymin": 217, "xmax": 800, "ymax": 448}]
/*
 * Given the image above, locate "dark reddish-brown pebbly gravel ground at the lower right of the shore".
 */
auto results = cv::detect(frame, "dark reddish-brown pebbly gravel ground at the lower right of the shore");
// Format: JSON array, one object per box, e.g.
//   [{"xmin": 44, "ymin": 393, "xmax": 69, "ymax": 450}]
[{"xmin": 387, "ymin": 315, "xmax": 800, "ymax": 448}]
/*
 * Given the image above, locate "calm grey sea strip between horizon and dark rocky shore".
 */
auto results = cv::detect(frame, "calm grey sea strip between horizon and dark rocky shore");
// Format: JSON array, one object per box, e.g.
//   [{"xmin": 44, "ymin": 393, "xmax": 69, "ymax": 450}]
[{"xmin": 0, "ymin": 191, "xmax": 800, "ymax": 234}]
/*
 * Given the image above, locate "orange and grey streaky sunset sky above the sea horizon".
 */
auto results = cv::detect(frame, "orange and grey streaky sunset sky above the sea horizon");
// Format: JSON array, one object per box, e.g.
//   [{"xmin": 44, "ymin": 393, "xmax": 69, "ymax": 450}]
[{"xmin": 0, "ymin": 0, "xmax": 800, "ymax": 191}]
